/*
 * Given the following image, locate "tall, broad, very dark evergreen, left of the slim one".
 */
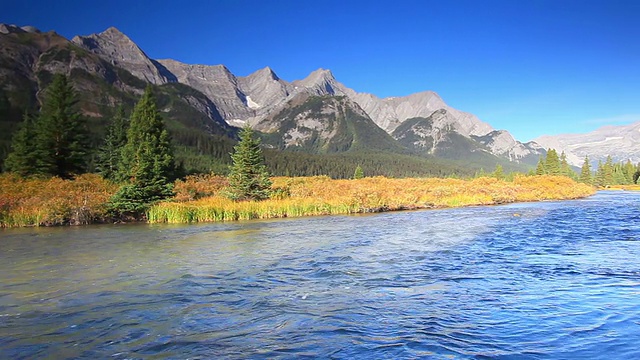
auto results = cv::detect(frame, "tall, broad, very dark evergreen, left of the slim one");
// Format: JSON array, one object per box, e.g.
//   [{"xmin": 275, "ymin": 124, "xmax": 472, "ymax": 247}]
[{"xmin": 35, "ymin": 74, "xmax": 88, "ymax": 179}]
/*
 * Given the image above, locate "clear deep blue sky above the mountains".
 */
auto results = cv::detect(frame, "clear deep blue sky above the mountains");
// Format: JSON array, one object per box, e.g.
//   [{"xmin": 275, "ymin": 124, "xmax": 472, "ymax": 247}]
[{"xmin": 0, "ymin": 0, "xmax": 640, "ymax": 141}]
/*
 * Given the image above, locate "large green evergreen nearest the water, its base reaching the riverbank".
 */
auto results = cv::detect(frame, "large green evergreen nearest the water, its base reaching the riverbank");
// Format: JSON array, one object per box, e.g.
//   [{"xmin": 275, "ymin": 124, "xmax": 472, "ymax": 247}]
[{"xmin": 111, "ymin": 86, "xmax": 175, "ymax": 217}]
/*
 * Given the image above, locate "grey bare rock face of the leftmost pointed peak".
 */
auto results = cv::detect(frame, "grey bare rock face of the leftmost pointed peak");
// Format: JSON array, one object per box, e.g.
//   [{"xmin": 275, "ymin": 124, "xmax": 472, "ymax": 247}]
[{"xmin": 71, "ymin": 27, "xmax": 170, "ymax": 84}]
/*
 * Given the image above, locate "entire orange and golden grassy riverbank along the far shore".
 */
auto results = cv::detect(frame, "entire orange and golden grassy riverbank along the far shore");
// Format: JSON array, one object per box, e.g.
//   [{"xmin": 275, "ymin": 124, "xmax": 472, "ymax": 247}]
[{"xmin": 0, "ymin": 174, "xmax": 595, "ymax": 227}]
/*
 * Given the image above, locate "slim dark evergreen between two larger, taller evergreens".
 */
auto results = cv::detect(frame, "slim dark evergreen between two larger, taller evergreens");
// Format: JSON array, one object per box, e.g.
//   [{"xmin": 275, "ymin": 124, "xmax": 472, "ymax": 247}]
[{"xmin": 98, "ymin": 106, "xmax": 129, "ymax": 181}]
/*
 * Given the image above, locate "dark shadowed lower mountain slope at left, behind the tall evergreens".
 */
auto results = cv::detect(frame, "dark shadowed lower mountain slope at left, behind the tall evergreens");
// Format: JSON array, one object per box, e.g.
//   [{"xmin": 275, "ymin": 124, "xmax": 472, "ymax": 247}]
[{"xmin": 0, "ymin": 24, "xmax": 235, "ymax": 172}]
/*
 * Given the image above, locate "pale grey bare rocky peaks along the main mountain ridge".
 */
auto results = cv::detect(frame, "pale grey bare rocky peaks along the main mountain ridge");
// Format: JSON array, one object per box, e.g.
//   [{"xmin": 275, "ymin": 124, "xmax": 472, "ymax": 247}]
[{"xmin": 69, "ymin": 28, "xmax": 544, "ymax": 164}]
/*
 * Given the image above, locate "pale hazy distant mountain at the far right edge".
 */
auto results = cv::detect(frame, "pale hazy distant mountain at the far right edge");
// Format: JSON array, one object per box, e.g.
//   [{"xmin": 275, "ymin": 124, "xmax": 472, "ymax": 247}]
[{"xmin": 534, "ymin": 121, "xmax": 640, "ymax": 166}]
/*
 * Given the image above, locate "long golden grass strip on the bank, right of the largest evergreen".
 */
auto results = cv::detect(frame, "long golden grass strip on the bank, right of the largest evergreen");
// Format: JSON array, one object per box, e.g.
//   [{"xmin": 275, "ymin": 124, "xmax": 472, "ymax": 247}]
[{"xmin": 148, "ymin": 175, "xmax": 595, "ymax": 223}]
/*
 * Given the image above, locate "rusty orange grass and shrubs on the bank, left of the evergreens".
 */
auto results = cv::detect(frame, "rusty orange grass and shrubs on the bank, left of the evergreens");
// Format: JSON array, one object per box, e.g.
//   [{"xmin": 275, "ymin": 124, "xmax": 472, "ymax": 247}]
[{"xmin": 0, "ymin": 174, "xmax": 117, "ymax": 227}]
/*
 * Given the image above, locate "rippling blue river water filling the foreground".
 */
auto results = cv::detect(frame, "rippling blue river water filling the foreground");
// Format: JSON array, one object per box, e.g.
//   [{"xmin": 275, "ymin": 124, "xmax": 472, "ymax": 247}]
[{"xmin": 0, "ymin": 192, "xmax": 640, "ymax": 360}]
